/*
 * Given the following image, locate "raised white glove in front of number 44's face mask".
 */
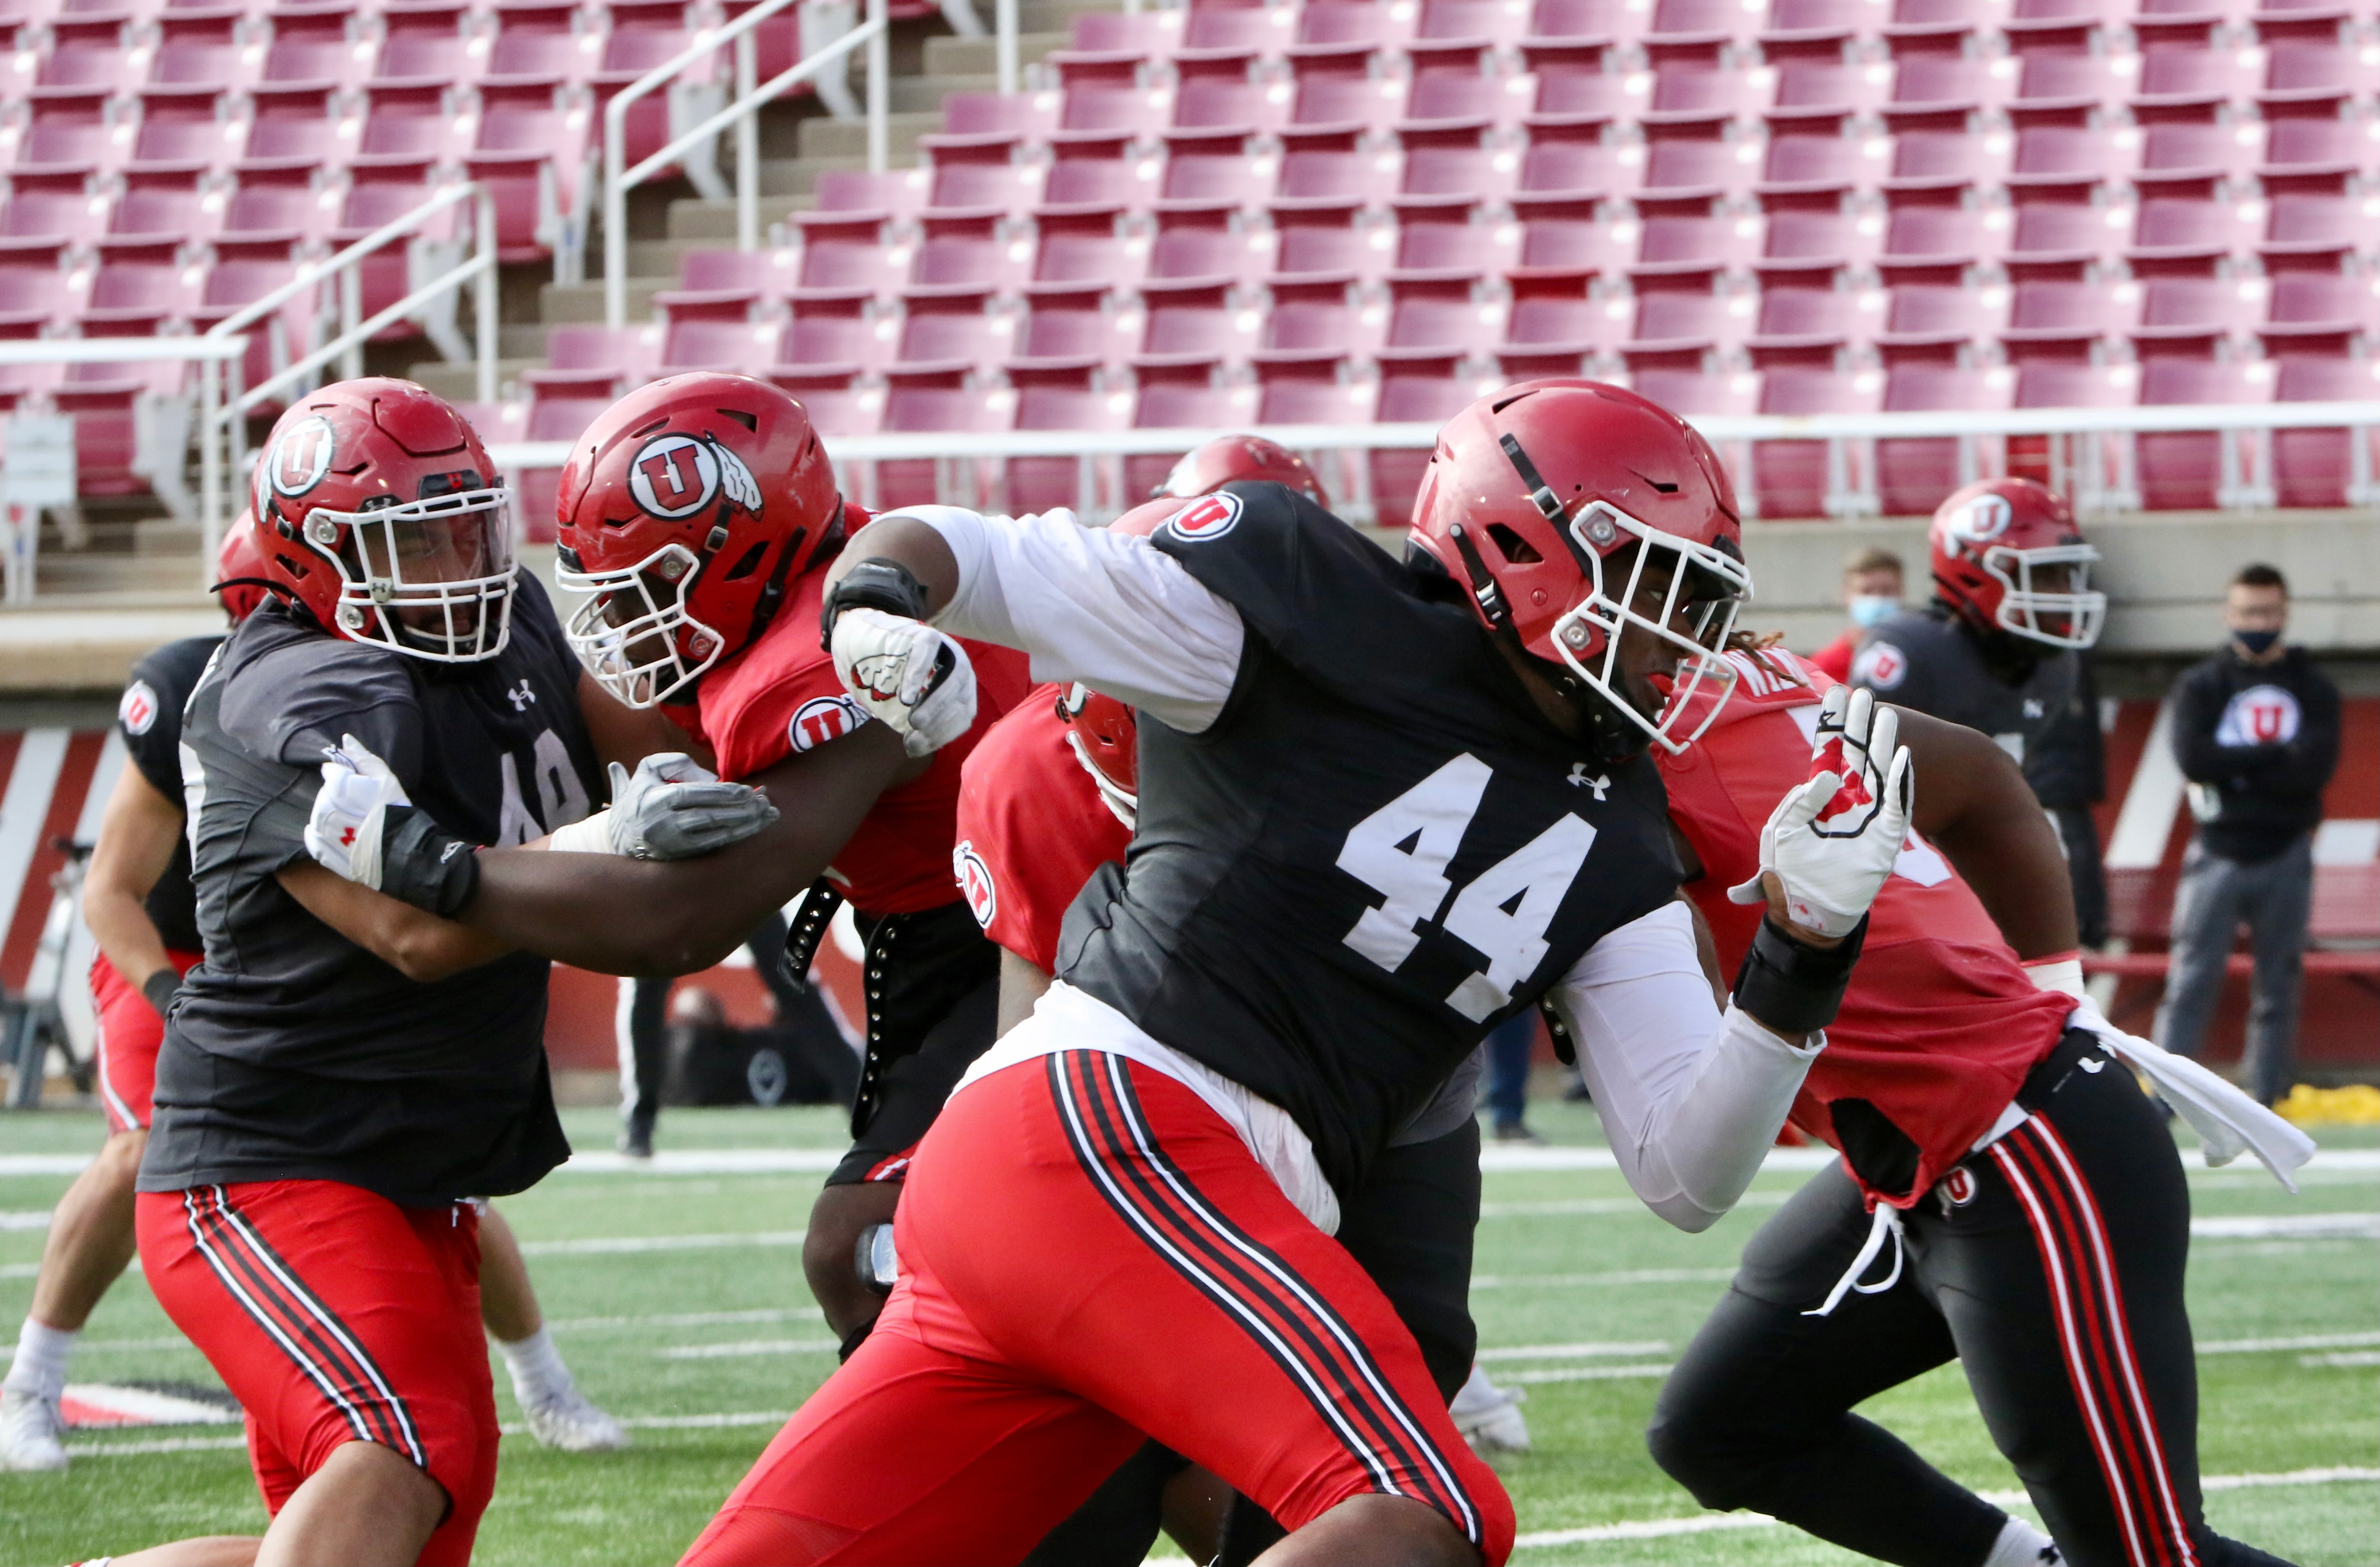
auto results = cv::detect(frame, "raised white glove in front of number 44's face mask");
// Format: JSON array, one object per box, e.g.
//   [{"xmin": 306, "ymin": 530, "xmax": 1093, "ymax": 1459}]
[{"xmin": 1728, "ymin": 686, "xmax": 1913, "ymax": 941}]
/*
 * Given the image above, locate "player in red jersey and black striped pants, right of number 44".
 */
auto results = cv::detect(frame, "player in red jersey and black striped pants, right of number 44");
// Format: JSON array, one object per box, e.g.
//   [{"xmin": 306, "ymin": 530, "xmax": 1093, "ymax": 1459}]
[{"xmin": 1652, "ymin": 650, "xmax": 2311, "ymax": 1567}]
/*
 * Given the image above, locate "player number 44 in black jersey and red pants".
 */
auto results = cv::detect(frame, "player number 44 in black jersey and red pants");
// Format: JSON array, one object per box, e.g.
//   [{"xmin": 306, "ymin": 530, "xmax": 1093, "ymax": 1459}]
[{"xmin": 662, "ymin": 381, "xmax": 1911, "ymax": 1562}]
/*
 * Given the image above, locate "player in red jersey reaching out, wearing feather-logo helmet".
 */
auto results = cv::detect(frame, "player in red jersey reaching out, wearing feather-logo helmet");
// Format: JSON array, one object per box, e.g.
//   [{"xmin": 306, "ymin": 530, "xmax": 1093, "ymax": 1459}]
[{"xmin": 300, "ymin": 374, "xmax": 1028, "ymax": 1345}]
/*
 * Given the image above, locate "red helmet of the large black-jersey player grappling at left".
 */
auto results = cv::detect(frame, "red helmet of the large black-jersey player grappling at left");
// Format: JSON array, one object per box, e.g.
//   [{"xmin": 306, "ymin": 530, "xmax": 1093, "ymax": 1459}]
[{"xmin": 252, "ymin": 376, "xmax": 514, "ymax": 665}]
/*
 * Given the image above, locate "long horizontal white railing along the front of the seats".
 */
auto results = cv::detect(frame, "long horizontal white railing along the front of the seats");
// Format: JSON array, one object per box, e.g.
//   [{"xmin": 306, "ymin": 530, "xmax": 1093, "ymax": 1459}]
[{"xmin": 488, "ymin": 400, "xmax": 2380, "ymax": 522}]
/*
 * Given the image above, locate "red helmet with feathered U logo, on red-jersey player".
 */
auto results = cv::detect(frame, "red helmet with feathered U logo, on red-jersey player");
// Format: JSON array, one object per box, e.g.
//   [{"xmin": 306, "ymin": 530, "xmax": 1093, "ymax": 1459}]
[{"xmin": 554, "ymin": 371, "xmax": 843, "ymax": 707}]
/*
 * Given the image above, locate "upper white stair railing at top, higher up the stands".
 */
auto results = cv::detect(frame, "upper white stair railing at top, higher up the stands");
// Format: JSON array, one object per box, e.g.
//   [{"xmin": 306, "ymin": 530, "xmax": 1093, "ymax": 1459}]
[{"xmin": 602, "ymin": 0, "xmax": 890, "ymax": 326}]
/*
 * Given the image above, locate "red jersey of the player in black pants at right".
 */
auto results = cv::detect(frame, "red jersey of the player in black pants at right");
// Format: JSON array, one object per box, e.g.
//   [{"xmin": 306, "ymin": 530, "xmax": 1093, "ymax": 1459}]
[{"xmin": 1661, "ymin": 653, "xmax": 2073, "ymax": 1208}]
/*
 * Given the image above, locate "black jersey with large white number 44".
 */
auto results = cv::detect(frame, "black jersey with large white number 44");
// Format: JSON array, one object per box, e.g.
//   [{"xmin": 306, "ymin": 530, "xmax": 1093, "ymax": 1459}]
[{"xmin": 1059, "ymin": 483, "xmax": 1678, "ymax": 1196}]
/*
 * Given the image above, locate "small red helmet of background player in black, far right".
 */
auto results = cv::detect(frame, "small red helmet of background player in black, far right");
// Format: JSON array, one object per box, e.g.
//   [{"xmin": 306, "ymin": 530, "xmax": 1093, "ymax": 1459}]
[{"xmin": 1925, "ymin": 479, "xmax": 2106, "ymax": 648}]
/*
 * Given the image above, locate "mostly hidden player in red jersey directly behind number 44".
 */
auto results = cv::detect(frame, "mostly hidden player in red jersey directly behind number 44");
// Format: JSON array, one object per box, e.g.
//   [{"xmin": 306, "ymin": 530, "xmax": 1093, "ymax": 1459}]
[{"xmin": 952, "ymin": 476, "xmax": 1494, "ymax": 1565}]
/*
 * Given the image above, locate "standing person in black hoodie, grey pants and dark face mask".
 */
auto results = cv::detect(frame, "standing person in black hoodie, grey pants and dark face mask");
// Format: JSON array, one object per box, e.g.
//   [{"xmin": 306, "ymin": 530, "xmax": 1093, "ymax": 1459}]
[{"xmin": 2156, "ymin": 564, "xmax": 2339, "ymax": 1105}]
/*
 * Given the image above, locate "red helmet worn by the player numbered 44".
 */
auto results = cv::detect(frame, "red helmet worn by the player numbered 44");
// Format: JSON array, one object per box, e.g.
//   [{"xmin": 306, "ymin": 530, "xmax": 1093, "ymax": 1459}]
[{"xmin": 1411, "ymin": 381, "xmax": 1752, "ymax": 753}]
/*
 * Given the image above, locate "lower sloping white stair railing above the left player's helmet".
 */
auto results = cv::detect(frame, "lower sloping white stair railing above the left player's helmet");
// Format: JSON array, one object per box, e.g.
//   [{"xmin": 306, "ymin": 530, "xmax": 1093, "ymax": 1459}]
[{"xmin": 197, "ymin": 181, "xmax": 498, "ymax": 581}]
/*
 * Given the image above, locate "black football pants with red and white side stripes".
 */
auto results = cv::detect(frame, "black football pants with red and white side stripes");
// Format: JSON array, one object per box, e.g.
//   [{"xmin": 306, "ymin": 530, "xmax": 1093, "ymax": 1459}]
[{"xmin": 1649, "ymin": 1034, "xmax": 2275, "ymax": 1567}]
